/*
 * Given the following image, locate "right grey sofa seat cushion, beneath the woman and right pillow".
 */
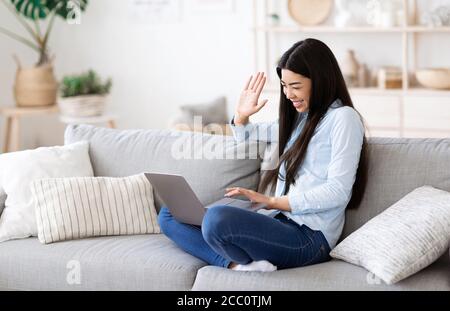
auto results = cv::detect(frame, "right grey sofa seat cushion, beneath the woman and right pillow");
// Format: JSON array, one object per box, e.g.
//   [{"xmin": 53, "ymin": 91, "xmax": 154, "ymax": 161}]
[{"xmin": 192, "ymin": 254, "xmax": 450, "ymax": 291}]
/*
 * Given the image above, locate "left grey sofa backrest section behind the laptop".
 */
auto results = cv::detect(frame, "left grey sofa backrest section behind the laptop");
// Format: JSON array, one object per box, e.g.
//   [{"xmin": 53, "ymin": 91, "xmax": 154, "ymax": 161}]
[{"xmin": 65, "ymin": 125, "xmax": 264, "ymax": 210}]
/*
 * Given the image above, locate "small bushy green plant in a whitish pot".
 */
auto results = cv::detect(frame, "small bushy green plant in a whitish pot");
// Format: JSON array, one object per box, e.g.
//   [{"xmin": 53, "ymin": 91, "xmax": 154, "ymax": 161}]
[{"xmin": 58, "ymin": 70, "xmax": 112, "ymax": 118}]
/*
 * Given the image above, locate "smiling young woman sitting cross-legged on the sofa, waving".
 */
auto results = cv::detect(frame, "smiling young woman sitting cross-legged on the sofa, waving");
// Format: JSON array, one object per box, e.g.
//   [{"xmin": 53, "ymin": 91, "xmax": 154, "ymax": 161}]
[{"xmin": 159, "ymin": 39, "xmax": 366, "ymax": 271}]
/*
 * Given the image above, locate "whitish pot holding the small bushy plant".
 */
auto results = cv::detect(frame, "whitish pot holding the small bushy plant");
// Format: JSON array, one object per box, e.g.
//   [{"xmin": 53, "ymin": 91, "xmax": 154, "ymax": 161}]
[{"xmin": 58, "ymin": 95, "xmax": 107, "ymax": 118}]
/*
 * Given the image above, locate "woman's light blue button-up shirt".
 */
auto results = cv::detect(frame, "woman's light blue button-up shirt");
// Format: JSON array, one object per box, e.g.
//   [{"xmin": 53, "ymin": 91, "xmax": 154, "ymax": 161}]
[{"xmin": 231, "ymin": 100, "xmax": 364, "ymax": 248}]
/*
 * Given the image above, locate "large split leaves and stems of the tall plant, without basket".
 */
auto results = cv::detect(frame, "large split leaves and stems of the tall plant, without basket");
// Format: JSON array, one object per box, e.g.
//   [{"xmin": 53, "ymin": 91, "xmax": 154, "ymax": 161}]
[{"xmin": 0, "ymin": 0, "xmax": 88, "ymax": 66}]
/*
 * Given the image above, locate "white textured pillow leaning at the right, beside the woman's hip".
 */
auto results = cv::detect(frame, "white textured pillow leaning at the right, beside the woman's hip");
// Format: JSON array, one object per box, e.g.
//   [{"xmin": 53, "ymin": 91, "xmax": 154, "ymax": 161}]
[{"xmin": 330, "ymin": 186, "xmax": 450, "ymax": 284}]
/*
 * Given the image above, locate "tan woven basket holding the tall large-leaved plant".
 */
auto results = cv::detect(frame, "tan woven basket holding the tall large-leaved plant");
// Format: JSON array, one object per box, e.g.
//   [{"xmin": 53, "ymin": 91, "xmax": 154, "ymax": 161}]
[{"xmin": 14, "ymin": 65, "xmax": 58, "ymax": 107}]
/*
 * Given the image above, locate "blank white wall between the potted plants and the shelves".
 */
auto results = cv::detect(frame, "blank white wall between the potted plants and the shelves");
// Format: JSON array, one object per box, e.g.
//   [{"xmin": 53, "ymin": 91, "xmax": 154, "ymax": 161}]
[{"xmin": 49, "ymin": 0, "xmax": 252, "ymax": 128}]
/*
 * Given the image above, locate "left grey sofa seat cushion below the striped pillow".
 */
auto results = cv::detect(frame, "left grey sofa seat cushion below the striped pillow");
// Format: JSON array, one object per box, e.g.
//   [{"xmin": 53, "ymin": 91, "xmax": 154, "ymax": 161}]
[{"xmin": 0, "ymin": 234, "xmax": 205, "ymax": 290}]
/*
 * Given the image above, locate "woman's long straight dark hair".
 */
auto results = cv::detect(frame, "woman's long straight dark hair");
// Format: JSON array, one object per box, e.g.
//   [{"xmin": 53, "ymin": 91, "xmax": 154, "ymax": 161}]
[{"xmin": 261, "ymin": 39, "xmax": 367, "ymax": 208}]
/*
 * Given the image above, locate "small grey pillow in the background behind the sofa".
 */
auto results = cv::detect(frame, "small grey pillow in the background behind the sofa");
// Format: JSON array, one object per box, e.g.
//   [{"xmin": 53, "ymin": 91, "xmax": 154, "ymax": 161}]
[{"xmin": 179, "ymin": 96, "xmax": 228, "ymax": 125}]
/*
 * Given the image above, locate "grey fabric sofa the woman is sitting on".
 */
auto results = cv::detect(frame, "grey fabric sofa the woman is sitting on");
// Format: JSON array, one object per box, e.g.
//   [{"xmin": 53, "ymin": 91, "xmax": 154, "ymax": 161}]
[{"xmin": 0, "ymin": 125, "xmax": 450, "ymax": 290}]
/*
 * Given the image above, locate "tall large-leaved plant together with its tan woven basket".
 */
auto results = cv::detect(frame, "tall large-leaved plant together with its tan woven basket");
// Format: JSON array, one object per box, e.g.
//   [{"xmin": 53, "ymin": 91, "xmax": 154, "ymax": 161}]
[{"xmin": 0, "ymin": 0, "xmax": 88, "ymax": 107}]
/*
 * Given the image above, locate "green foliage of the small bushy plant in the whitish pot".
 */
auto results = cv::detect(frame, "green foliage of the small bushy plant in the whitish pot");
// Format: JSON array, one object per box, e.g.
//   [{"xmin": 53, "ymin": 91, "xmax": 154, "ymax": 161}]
[{"xmin": 61, "ymin": 70, "xmax": 112, "ymax": 97}]
